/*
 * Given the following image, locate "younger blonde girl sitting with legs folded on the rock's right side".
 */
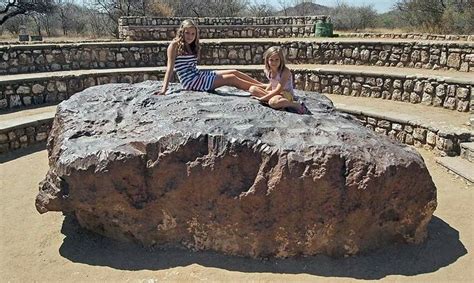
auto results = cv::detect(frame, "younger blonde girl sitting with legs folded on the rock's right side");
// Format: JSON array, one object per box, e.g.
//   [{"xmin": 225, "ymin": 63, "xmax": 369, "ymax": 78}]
[{"xmin": 249, "ymin": 46, "xmax": 310, "ymax": 114}]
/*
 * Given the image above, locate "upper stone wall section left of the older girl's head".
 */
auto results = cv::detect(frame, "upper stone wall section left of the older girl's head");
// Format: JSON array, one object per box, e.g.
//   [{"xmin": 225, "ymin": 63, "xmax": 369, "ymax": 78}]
[{"xmin": 0, "ymin": 42, "xmax": 167, "ymax": 75}]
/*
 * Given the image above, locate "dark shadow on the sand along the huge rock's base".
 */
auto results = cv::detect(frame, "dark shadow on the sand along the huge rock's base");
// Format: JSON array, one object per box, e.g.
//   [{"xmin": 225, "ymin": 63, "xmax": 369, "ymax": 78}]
[{"xmin": 60, "ymin": 216, "xmax": 467, "ymax": 279}]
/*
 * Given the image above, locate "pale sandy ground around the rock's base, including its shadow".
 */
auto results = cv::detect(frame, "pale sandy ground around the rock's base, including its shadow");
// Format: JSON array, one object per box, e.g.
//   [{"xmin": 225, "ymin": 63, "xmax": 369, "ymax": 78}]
[{"xmin": 0, "ymin": 146, "xmax": 474, "ymax": 282}]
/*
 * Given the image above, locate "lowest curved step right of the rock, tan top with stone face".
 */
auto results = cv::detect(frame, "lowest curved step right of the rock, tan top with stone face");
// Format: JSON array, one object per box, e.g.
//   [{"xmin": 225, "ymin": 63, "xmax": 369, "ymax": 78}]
[{"xmin": 326, "ymin": 94, "xmax": 474, "ymax": 156}]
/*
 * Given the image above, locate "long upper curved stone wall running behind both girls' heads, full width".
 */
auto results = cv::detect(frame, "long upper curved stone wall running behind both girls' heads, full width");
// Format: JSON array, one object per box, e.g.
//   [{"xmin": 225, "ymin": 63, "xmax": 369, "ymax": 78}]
[{"xmin": 0, "ymin": 41, "xmax": 474, "ymax": 75}]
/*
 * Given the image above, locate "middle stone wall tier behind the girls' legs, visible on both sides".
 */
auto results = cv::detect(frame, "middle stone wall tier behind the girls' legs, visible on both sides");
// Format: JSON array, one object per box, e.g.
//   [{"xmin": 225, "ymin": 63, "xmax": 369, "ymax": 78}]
[{"xmin": 0, "ymin": 67, "xmax": 474, "ymax": 112}]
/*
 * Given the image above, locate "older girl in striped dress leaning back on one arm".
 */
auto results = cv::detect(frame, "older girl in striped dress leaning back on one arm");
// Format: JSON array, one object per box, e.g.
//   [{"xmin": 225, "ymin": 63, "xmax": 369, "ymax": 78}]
[{"xmin": 156, "ymin": 20, "xmax": 263, "ymax": 95}]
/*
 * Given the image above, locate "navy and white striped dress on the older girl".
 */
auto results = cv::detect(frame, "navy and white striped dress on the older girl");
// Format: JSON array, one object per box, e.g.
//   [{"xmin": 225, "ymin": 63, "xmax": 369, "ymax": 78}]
[{"xmin": 174, "ymin": 55, "xmax": 217, "ymax": 91}]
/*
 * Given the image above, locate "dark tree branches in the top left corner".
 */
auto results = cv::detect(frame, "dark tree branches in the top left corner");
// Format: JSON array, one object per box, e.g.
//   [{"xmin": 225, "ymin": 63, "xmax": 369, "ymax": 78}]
[{"xmin": 0, "ymin": 0, "xmax": 53, "ymax": 25}]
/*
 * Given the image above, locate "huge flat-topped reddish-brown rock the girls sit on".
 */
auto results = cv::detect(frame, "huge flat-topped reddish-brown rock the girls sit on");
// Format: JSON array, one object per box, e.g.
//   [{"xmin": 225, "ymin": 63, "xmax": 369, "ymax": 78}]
[{"xmin": 36, "ymin": 81, "xmax": 436, "ymax": 257}]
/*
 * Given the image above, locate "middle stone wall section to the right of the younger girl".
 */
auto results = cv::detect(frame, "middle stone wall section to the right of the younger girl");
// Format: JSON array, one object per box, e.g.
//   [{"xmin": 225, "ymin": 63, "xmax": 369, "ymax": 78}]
[{"xmin": 295, "ymin": 70, "xmax": 474, "ymax": 112}]
